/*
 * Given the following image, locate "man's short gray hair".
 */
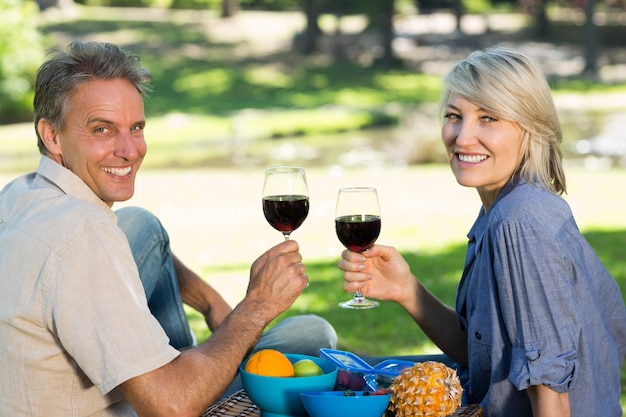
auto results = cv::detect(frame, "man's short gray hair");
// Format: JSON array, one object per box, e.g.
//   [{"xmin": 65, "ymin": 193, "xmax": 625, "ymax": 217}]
[{"xmin": 33, "ymin": 41, "xmax": 152, "ymax": 155}]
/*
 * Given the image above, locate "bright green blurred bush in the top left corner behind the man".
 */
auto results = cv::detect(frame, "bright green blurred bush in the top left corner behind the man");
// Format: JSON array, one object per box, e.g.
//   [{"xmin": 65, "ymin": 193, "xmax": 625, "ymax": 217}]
[{"xmin": 0, "ymin": 0, "xmax": 44, "ymax": 123}]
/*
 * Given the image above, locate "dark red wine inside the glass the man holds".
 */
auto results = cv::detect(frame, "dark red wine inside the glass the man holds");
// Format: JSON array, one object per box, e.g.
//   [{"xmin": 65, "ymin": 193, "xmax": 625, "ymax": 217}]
[{"xmin": 263, "ymin": 195, "xmax": 309, "ymax": 232}]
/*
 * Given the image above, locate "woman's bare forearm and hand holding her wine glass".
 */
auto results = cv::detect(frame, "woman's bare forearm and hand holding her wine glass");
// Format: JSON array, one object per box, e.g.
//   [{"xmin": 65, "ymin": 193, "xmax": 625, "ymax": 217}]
[{"xmin": 339, "ymin": 245, "xmax": 467, "ymax": 364}]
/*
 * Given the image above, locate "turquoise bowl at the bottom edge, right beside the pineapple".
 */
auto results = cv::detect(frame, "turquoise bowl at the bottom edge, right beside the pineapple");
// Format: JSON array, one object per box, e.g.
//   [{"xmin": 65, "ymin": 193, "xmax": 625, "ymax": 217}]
[{"xmin": 300, "ymin": 391, "xmax": 391, "ymax": 417}]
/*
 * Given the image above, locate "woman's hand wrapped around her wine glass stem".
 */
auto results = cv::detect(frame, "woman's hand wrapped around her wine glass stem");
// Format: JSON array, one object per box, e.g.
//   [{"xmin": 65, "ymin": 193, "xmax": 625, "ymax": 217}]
[{"xmin": 338, "ymin": 245, "xmax": 417, "ymax": 306}]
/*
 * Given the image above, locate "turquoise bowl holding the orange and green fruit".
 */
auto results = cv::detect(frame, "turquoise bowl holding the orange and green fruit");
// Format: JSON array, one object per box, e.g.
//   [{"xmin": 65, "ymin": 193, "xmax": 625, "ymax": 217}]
[{"xmin": 239, "ymin": 353, "xmax": 336, "ymax": 417}]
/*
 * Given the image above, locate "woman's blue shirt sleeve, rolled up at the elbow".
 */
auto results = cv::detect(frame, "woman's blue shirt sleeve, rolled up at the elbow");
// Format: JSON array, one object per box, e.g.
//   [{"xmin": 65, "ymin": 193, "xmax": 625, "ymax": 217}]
[{"xmin": 493, "ymin": 221, "xmax": 582, "ymax": 392}]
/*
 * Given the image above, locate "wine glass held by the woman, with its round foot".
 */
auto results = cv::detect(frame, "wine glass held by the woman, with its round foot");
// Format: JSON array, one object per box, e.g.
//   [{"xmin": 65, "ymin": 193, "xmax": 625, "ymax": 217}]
[{"xmin": 335, "ymin": 187, "xmax": 380, "ymax": 309}]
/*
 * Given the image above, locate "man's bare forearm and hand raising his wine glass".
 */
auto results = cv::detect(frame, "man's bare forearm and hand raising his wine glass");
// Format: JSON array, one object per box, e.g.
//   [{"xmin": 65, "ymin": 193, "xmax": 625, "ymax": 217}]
[{"xmin": 120, "ymin": 240, "xmax": 308, "ymax": 417}]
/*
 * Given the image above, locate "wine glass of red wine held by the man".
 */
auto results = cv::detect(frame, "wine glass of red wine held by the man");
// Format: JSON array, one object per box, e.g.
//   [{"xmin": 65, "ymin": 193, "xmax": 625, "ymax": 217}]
[{"xmin": 263, "ymin": 165, "xmax": 309, "ymax": 240}]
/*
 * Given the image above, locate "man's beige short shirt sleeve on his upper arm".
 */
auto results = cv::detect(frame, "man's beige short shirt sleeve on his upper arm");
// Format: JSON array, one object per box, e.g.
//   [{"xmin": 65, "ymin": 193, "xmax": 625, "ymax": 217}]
[{"xmin": 46, "ymin": 224, "xmax": 179, "ymax": 394}]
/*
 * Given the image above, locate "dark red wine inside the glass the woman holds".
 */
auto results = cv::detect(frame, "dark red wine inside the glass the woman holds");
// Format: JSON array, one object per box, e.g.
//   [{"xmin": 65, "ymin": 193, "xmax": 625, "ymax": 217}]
[{"xmin": 335, "ymin": 214, "xmax": 380, "ymax": 252}]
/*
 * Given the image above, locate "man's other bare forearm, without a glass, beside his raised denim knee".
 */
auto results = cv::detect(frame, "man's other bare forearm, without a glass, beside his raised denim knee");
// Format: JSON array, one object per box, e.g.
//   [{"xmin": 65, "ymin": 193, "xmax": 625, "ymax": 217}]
[{"xmin": 172, "ymin": 254, "xmax": 232, "ymax": 332}]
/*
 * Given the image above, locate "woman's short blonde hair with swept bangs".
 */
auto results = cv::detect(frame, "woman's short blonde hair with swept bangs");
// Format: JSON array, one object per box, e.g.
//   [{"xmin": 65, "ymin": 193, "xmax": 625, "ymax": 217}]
[{"xmin": 441, "ymin": 47, "xmax": 566, "ymax": 194}]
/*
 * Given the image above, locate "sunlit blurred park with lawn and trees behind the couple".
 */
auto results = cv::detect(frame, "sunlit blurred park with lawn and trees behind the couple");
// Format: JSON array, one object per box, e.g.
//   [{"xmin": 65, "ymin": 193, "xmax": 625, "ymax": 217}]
[{"xmin": 0, "ymin": 0, "xmax": 626, "ymax": 410}]
